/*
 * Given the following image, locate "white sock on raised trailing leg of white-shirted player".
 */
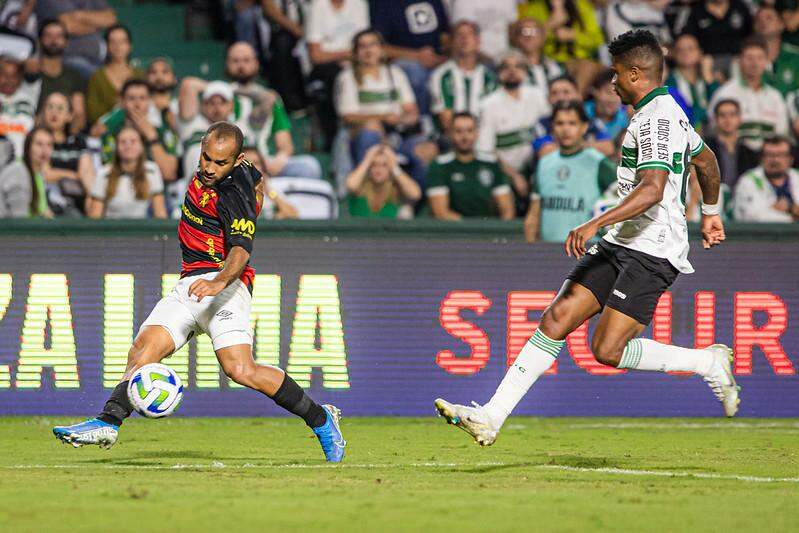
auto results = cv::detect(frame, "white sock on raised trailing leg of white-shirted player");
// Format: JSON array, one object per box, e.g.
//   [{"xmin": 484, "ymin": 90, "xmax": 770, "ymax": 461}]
[{"xmin": 619, "ymin": 339, "xmax": 713, "ymax": 376}]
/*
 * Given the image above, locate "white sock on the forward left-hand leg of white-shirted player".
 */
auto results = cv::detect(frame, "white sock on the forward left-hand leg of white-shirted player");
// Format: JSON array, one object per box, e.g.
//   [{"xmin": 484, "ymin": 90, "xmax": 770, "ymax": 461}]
[{"xmin": 483, "ymin": 329, "xmax": 564, "ymax": 429}]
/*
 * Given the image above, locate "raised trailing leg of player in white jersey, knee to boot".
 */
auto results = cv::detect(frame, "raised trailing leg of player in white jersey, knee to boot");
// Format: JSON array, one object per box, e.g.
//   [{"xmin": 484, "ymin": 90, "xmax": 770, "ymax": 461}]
[{"xmin": 591, "ymin": 307, "xmax": 741, "ymax": 416}]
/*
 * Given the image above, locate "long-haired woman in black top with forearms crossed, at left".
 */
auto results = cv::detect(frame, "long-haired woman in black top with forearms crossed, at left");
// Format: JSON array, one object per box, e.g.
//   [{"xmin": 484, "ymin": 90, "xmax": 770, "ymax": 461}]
[{"xmin": 39, "ymin": 92, "xmax": 94, "ymax": 215}]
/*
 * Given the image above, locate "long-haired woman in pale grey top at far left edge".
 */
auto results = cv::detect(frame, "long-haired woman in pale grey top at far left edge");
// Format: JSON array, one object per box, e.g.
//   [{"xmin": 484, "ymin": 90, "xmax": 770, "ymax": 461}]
[{"xmin": 0, "ymin": 127, "xmax": 53, "ymax": 218}]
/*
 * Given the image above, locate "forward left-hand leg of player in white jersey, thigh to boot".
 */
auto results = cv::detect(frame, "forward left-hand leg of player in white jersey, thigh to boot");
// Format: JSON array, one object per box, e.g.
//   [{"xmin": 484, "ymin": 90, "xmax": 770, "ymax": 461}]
[{"xmin": 435, "ymin": 281, "xmax": 600, "ymax": 446}]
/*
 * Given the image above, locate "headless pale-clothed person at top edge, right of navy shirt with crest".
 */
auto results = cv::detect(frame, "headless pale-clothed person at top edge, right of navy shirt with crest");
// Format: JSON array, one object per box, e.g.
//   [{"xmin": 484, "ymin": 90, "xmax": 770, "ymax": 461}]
[{"xmin": 449, "ymin": 0, "xmax": 519, "ymax": 61}]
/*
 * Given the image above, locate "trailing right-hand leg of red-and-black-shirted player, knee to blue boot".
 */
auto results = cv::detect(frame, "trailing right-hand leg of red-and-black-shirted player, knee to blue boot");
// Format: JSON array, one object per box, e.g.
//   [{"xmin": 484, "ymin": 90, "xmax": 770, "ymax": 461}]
[{"xmin": 216, "ymin": 344, "xmax": 347, "ymax": 463}]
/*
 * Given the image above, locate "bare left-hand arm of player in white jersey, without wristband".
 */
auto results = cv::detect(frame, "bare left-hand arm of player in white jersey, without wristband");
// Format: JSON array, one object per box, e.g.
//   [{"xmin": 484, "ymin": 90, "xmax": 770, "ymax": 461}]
[{"xmin": 566, "ymin": 168, "xmax": 669, "ymax": 258}]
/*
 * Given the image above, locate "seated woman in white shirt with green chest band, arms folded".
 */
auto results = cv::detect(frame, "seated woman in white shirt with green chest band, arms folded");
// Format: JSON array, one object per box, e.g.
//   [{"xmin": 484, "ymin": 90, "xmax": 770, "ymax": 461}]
[{"xmin": 336, "ymin": 30, "xmax": 435, "ymax": 187}]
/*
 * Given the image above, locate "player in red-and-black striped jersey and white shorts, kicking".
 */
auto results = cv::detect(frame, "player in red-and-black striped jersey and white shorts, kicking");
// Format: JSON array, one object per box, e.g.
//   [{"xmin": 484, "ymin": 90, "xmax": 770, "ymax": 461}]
[{"xmin": 53, "ymin": 122, "xmax": 346, "ymax": 462}]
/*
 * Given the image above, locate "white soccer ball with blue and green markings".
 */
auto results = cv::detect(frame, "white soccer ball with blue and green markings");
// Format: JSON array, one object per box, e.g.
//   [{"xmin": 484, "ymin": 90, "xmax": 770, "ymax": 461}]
[{"xmin": 128, "ymin": 363, "xmax": 183, "ymax": 418}]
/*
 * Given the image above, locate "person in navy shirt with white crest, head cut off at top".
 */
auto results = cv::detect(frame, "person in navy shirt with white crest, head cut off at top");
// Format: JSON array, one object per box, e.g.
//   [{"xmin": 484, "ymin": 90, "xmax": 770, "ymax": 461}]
[{"xmin": 370, "ymin": 0, "xmax": 450, "ymax": 115}]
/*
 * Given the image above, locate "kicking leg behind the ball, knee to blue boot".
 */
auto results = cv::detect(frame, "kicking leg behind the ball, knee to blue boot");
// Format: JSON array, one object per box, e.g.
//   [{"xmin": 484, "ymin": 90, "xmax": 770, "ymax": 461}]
[{"xmin": 53, "ymin": 326, "xmax": 175, "ymax": 448}]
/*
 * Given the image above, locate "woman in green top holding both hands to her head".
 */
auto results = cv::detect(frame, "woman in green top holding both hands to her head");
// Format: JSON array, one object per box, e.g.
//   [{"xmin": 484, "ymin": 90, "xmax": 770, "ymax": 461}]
[{"xmin": 346, "ymin": 144, "xmax": 422, "ymax": 218}]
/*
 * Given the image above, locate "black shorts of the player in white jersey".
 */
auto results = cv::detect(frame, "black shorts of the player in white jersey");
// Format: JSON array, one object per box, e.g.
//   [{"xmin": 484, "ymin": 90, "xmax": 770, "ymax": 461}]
[{"xmin": 567, "ymin": 239, "xmax": 680, "ymax": 326}]
